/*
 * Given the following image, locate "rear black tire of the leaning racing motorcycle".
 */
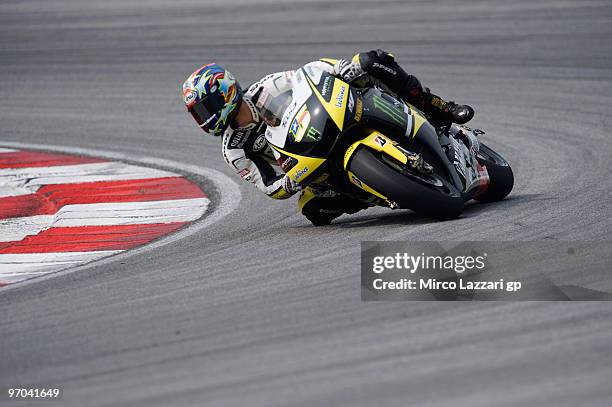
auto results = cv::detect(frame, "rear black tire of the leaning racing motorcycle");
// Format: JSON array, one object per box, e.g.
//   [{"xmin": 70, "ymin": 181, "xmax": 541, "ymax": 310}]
[{"xmin": 474, "ymin": 144, "xmax": 514, "ymax": 202}]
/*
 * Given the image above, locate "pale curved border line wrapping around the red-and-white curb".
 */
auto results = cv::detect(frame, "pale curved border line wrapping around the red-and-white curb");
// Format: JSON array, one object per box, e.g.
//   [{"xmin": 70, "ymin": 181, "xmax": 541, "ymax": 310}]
[{"xmin": 0, "ymin": 141, "xmax": 241, "ymax": 291}]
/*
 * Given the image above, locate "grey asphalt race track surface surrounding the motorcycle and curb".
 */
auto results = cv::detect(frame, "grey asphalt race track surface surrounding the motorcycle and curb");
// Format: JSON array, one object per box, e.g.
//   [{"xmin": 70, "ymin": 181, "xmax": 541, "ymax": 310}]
[{"xmin": 0, "ymin": 0, "xmax": 612, "ymax": 406}]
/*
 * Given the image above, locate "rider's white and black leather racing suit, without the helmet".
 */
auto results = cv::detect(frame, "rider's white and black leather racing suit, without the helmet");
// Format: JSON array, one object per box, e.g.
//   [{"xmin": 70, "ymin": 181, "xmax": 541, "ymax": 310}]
[{"xmin": 223, "ymin": 50, "xmax": 473, "ymax": 225}]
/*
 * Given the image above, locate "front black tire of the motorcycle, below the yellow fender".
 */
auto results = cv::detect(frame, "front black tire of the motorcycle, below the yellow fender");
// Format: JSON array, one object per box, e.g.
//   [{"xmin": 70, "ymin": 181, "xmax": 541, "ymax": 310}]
[{"xmin": 349, "ymin": 147, "xmax": 463, "ymax": 220}]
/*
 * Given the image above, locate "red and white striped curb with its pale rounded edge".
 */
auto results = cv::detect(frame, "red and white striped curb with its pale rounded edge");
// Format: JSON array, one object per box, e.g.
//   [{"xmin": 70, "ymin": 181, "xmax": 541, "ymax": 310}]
[{"xmin": 0, "ymin": 143, "xmax": 240, "ymax": 286}]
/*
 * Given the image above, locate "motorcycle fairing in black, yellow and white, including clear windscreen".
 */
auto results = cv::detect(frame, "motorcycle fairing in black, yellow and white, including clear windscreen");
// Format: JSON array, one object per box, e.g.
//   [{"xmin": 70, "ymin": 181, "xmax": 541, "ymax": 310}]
[{"xmin": 266, "ymin": 68, "xmax": 480, "ymax": 205}]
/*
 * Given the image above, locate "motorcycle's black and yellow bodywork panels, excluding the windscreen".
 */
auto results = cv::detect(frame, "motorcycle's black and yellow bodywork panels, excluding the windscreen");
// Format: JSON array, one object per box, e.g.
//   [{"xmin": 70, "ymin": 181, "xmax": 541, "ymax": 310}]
[{"xmin": 271, "ymin": 73, "xmax": 466, "ymax": 217}]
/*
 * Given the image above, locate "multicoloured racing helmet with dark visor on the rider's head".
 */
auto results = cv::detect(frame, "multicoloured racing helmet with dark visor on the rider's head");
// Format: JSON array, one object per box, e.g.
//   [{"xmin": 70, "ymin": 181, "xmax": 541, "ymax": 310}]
[{"xmin": 183, "ymin": 63, "xmax": 242, "ymax": 136}]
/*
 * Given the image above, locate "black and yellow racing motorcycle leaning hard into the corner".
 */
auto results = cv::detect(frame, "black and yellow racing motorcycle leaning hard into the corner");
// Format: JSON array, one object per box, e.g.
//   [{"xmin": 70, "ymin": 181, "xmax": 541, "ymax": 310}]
[{"xmin": 266, "ymin": 66, "xmax": 514, "ymax": 220}]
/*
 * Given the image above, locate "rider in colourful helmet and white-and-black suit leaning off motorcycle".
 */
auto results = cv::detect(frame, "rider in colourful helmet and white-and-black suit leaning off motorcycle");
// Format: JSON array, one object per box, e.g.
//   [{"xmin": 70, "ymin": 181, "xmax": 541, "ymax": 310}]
[{"xmin": 183, "ymin": 49, "xmax": 474, "ymax": 225}]
